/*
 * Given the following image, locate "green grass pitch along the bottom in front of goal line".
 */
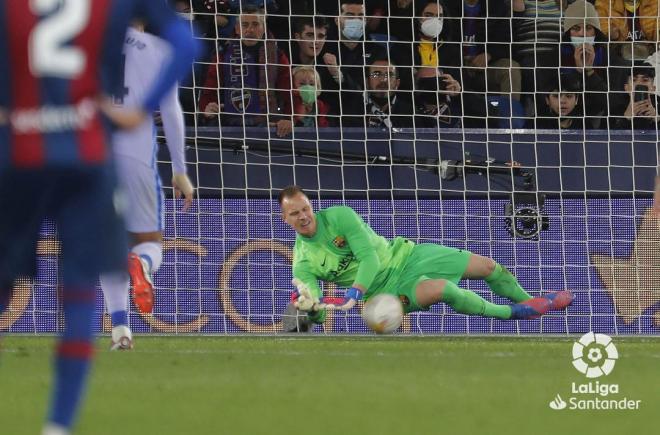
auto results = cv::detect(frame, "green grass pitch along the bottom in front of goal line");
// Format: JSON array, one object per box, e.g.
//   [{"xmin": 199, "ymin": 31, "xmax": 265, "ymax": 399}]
[{"xmin": 0, "ymin": 336, "xmax": 660, "ymax": 435}]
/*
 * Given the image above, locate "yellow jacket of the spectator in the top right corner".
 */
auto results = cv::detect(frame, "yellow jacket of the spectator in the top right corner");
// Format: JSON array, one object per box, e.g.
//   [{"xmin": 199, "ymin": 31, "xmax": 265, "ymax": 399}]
[{"xmin": 594, "ymin": 0, "xmax": 660, "ymax": 41}]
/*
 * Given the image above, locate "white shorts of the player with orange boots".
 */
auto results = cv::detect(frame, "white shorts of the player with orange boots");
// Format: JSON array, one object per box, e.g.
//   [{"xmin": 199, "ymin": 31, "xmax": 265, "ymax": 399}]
[{"xmin": 115, "ymin": 155, "xmax": 164, "ymax": 233}]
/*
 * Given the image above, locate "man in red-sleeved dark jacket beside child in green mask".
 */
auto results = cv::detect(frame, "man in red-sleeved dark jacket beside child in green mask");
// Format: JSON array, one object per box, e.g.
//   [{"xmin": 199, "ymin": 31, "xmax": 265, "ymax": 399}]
[{"xmin": 200, "ymin": 6, "xmax": 292, "ymax": 137}]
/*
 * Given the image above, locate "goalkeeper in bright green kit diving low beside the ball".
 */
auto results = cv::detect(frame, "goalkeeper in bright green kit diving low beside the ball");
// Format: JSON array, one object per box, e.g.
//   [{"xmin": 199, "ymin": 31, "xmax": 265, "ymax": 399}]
[{"xmin": 279, "ymin": 186, "xmax": 573, "ymax": 323}]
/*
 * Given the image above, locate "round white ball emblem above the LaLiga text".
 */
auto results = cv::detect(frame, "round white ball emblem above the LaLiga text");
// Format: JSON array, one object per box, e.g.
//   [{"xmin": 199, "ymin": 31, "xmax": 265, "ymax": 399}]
[{"xmin": 573, "ymin": 332, "xmax": 619, "ymax": 378}]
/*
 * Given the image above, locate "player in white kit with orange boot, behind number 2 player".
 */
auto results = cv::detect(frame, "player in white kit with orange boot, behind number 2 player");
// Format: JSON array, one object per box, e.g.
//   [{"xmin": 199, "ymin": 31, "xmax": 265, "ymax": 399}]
[{"xmin": 101, "ymin": 25, "xmax": 194, "ymax": 350}]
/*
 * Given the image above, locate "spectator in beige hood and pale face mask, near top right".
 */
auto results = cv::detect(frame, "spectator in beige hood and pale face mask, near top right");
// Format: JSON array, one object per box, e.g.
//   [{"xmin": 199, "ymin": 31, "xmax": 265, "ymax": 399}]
[{"xmin": 561, "ymin": 0, "xmax": 622, "ymax": 128}]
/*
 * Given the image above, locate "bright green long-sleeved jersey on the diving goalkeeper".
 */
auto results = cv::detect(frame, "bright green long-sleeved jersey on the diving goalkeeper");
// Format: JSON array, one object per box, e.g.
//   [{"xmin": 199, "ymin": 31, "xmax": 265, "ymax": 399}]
[{"xmin": 293, "ymin": 206, "xmax": 414, "ymax": 299}]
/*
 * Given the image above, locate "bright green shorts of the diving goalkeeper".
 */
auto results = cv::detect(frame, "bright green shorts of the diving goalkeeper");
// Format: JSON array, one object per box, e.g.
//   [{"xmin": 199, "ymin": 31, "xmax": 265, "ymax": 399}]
[{"xmin": 378, "ymin": 244, "xmax": 472, "ymax": 313}]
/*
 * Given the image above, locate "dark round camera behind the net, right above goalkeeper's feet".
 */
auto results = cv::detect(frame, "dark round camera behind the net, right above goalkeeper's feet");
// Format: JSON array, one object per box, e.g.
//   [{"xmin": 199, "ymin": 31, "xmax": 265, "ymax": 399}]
[{"xmin": 504, "ymin": 193, "xmax": 550, "ymax": 240}]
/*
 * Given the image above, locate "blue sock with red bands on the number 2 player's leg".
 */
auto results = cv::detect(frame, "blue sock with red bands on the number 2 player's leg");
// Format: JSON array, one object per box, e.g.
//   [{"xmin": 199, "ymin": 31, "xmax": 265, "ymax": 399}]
[{"xmin": 48, "ymin": 286, "xmax": 95, "ymax": 428}]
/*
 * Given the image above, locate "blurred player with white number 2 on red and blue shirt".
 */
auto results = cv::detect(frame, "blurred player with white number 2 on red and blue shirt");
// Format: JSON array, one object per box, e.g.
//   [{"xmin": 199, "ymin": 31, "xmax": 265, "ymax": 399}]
[{"xmin": 0, "ymin": 0, "xmax": 196, "ymax": 435}]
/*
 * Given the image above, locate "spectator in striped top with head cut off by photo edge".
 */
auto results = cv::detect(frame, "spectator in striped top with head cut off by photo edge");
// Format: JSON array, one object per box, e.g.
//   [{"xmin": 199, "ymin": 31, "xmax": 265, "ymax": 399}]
[{"xmin": 511, "ymin": 0, "xmax": 566, "ymax": 109}]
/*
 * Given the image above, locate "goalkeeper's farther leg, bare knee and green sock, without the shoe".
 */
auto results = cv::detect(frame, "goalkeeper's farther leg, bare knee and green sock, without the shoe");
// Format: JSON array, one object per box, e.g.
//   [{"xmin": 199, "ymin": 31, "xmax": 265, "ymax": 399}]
[{"xmin": 463, "ymin": 253, "xmax": 532, "ymax": 302}]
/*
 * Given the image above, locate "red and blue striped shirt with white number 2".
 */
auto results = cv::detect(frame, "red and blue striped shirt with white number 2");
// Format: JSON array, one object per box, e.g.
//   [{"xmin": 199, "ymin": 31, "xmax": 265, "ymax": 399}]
[{"xmin": 0, "ymin": 0, "xmax": 196, "ymax": 169}]
